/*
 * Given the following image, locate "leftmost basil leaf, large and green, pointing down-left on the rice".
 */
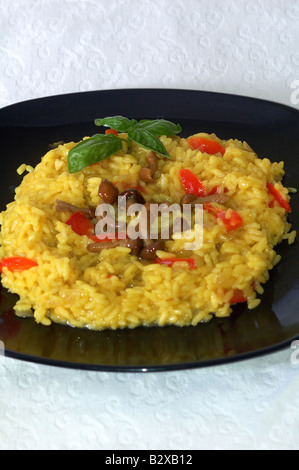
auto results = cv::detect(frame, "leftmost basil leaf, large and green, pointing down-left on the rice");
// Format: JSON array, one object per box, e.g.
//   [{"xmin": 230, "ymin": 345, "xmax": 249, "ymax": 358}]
[{"xmin": 67, "ymin": 134, "xmax": 122, "ymax": 173}]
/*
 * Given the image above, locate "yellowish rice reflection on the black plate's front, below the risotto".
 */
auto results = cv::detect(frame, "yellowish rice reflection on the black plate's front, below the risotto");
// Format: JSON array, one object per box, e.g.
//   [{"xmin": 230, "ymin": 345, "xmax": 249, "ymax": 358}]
[{"xmin": 0, "ymin": 282, "xmax": 288, "ymax": 370}]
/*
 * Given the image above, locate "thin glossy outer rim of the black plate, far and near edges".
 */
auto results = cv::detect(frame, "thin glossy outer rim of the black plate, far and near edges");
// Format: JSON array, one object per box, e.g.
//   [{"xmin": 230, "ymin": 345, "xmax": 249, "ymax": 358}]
[{"xmin": 0, "ymin": 88, "xmax": 299, "ymax": 372}]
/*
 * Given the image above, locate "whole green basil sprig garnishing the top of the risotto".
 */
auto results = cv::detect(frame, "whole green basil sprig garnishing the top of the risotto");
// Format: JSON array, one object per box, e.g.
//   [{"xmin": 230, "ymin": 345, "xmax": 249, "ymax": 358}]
[{"xmin": 68, "ymin": 116, "xmax": 182, "ymax": 173}]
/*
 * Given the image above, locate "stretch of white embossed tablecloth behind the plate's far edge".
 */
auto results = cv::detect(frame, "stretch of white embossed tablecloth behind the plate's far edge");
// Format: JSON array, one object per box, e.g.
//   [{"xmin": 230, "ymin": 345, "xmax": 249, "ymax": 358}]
[{"xmin": 0, "ymin": 0, "xmax": 299, "ymax": 106}]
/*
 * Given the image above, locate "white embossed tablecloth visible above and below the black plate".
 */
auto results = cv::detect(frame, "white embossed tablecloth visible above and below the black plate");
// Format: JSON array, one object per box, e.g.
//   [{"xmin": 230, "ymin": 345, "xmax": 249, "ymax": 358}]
[{"xmin": 0, "ymin": 0, "xmax": 299, "ymax": 450}]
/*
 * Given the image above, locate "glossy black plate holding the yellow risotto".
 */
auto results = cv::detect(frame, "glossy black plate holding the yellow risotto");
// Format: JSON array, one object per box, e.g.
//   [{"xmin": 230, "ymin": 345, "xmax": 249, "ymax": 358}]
[{"xmin": 0, "ymin": 89, "xmax": 299, "ymax": 371}]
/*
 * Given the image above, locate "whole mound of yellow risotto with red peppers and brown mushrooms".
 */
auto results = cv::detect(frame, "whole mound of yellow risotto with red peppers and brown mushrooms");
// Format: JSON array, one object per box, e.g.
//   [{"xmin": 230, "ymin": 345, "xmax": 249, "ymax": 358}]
[{"xmin": 0, "ymin": 117, "xmax": 296, "ymax": 330}]
